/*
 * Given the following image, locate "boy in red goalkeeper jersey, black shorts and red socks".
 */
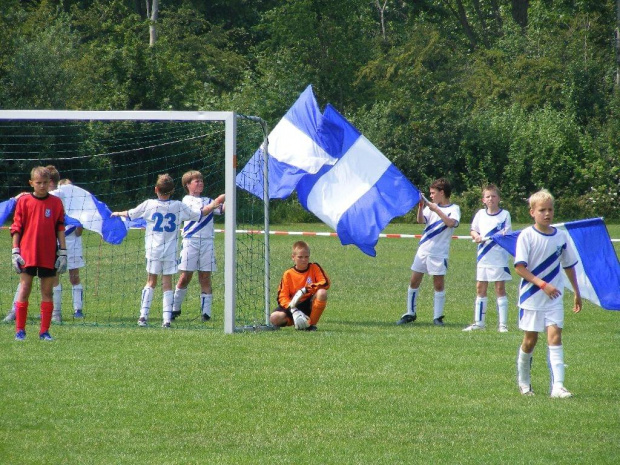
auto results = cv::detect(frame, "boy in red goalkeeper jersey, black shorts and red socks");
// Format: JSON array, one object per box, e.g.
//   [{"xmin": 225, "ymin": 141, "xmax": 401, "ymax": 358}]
[{"xmin": 11, "ymin": 166, "xmax": 67, "ymax": 341}]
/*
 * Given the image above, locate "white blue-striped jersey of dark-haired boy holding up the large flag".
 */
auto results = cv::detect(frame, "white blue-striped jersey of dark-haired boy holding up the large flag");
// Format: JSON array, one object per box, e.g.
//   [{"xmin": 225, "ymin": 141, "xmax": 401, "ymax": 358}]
[{"xmin": 417, "ymin": 203, "xmax": 461, "ymax": 258}]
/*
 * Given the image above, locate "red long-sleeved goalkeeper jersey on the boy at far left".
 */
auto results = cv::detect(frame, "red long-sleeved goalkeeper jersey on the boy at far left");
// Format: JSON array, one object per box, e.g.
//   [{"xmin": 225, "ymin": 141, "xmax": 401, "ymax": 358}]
[{"xmin": 11, "ymin": 194, "xmax": 65, "ymax": 269}]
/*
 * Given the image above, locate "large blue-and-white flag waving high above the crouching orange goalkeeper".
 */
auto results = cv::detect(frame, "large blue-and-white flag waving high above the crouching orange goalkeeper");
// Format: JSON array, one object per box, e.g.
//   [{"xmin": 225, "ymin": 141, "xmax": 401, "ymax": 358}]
[{"xmin": 237, "ymin": 86, "xmax": 420, "ymax": 257}]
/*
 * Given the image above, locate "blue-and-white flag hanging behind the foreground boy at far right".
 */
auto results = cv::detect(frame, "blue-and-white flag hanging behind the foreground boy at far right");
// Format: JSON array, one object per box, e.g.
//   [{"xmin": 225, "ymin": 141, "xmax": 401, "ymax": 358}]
[{"xmin": 491, "ymin": 218, "xmax": 620, "ymax": 310}]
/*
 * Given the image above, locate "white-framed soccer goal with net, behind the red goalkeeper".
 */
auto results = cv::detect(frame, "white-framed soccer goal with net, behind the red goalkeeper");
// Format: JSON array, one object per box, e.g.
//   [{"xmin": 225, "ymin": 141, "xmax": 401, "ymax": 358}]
[{"xmin": 0, "ymin": 110, "xmax": 270, "ymax": 333}]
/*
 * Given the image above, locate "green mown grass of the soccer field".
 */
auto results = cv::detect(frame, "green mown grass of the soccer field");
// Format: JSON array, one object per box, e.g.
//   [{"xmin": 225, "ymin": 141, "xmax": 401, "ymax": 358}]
[{"xmin": 0, "ymin": 225, "xmax": 620, "ymax": 464}]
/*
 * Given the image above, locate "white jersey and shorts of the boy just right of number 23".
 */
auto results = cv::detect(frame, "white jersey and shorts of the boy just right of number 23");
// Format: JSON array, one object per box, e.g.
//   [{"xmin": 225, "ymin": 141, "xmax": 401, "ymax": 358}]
[{"xmin": 179, "ymin": 195, "xmax": 222, "ymax": 271}]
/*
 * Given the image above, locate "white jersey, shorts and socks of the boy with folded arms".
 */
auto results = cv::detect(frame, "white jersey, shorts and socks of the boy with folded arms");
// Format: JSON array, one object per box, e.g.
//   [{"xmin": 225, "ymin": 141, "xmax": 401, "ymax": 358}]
[{"xmin": 465, "ymin": 208, "xmax": 512, "ymax": 332}]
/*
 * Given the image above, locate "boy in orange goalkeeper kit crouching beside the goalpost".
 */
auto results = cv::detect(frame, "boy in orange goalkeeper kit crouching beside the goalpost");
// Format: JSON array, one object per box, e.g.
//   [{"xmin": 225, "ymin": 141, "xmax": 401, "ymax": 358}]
[{"xmin": 269, "ymin": 241, "xmax": 330, "ymax": 331}]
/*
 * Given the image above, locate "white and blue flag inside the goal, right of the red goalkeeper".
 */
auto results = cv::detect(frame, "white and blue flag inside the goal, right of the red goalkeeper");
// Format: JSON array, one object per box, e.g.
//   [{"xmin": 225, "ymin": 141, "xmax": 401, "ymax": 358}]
[{"xmin": 54, "ymin": 184, "xmax": 127, "ymax": 244}]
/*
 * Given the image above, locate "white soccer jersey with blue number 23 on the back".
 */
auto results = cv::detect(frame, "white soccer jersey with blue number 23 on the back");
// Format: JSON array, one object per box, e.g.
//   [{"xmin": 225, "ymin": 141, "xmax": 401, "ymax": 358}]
[{"xmin": 127, "ymin": 199, "xmax": 201, "ymax": 261}]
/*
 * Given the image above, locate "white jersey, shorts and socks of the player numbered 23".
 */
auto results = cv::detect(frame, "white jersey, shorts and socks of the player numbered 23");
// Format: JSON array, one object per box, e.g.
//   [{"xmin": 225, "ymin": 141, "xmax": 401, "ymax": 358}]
[{"xmin": 127, "ymin": 199, "xmax": 202, "ymax": 326}]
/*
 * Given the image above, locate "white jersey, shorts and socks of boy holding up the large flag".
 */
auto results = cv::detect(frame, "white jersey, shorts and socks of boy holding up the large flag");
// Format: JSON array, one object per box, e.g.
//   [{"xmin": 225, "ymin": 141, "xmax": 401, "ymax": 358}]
[{"xmin": 399, "ymin": 204, "xmax": 461, "ymax": 324}]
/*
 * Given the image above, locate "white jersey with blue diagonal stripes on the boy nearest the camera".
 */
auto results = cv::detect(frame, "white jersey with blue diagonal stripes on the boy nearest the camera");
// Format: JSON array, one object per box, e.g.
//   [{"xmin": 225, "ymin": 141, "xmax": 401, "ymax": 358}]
[{"xmin": 515, "ymin": 226, "xmax": 578, "ymax": 311}]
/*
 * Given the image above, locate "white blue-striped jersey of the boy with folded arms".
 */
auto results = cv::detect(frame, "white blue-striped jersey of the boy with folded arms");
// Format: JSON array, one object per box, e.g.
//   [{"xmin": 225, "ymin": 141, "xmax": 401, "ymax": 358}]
[{"xmin": 471, "ymin": 208, "xmax": 512, "ymax": 268}]
